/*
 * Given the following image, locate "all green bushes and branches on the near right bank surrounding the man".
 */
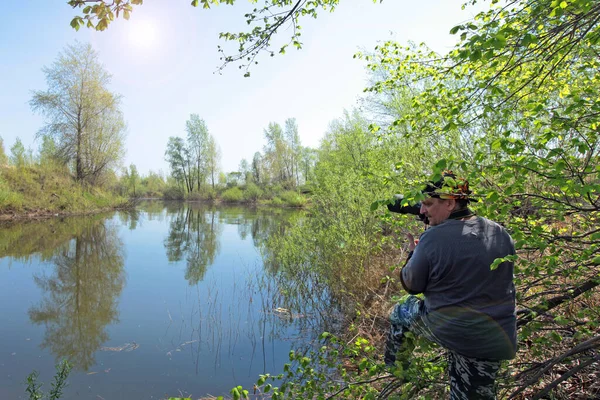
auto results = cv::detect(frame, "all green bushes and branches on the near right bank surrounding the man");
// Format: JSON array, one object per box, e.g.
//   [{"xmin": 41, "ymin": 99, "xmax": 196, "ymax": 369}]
[{"xmin": 237, "ymin": 1, "xmax": 600, "ymax": 399}]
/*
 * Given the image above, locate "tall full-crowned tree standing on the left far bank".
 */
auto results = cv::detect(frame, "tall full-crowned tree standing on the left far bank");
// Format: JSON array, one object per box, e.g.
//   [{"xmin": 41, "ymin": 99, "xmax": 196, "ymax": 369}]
[{"xmin": 29, "ymin": 43, "xmax": 125, "ymax": 184}]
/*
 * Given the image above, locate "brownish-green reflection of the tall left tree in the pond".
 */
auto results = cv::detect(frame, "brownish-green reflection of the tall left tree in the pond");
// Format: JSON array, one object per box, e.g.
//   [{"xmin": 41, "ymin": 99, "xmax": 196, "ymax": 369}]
[{"xmin": 28, "ymin": 220, "xmax": 125, "ymax": 371}]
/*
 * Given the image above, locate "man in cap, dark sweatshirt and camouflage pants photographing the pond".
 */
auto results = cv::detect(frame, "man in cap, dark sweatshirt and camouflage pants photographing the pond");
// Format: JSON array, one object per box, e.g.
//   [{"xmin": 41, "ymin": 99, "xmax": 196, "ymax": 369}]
[{"xmin": 385, "ymin": 171, "xmax": 516, "ymax": 400}]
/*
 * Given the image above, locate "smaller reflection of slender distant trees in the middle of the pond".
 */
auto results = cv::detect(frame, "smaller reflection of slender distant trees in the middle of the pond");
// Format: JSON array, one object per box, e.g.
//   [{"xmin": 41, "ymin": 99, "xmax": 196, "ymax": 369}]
[{"xmin": 165, "ymin": 207, "xmax": 222, "ymax": 285}]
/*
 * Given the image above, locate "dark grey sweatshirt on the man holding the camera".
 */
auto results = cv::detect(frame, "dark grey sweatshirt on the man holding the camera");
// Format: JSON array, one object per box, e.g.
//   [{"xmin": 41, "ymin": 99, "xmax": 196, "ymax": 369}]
[{"xmin": 402, "ymin": 217, "xmax": 516, "ymax": 359}]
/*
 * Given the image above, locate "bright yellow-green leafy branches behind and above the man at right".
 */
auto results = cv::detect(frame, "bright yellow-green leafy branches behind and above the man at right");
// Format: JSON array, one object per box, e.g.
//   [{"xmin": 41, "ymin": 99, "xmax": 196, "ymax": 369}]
[{"xmin": 356, "ymin": 1, "xmax": 600, "ymax": 398}]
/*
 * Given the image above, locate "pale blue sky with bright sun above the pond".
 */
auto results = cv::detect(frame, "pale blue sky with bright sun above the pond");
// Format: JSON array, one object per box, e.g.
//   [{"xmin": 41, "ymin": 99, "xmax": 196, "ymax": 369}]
[{"xmin": 0, "ymin": 0, "xmax": 476, "ymax": 174}]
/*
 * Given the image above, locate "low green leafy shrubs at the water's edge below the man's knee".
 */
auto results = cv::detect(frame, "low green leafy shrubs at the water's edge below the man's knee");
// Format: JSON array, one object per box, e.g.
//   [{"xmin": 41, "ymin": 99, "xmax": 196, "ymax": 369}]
[{"xmin": 238, "ymin": 332, "xmax": 447, "ymax": 400}]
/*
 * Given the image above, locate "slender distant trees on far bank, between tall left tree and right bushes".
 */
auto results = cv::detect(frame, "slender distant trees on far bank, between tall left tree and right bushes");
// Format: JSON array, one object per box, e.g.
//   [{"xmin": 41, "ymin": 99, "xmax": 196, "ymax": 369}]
[{"xmin": 163, "ymin": 114, "xmax": 316, "ymax": 206}]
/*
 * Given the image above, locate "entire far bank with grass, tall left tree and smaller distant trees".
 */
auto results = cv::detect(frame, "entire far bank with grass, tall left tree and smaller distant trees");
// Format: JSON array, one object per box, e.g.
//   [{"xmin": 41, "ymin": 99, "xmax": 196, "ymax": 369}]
[{"xmin": 0, "ymin": 43, "xmax": 316, "ymax": 214}]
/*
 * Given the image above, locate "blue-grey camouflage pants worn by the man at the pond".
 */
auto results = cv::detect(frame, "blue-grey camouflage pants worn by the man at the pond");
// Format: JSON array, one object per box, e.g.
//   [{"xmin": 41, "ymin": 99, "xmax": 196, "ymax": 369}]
[{"xmin": 385, "ymin": 296, "xmax": 500, "ymax": 400}]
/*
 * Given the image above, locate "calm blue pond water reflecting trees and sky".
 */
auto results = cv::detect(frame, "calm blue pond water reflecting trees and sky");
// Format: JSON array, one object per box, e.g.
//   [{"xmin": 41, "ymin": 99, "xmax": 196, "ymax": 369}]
[{"xmin": 0, "ymin": 202, "xmax": 320, "ymax": 400}]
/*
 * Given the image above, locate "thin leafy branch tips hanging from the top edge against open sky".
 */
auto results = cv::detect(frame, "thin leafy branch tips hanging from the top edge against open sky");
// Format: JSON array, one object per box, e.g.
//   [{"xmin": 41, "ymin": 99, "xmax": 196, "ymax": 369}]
[{"xmin": 67, "ymin": 0, "xmax": 356, "ymax": 72}]
